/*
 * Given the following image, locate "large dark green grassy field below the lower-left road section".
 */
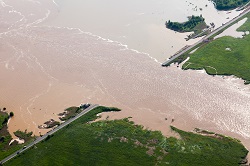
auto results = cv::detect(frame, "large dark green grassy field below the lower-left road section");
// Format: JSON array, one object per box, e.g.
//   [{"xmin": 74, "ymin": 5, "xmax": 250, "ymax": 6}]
[{"xmin": 6, "ymin": 107, "xmax": 247, "ymax": 166}]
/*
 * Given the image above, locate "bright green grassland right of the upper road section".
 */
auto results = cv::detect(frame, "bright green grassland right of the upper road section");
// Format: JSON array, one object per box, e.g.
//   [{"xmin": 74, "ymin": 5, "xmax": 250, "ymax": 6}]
[{"xmin": 182, "ymin": 14, "xmax": 250, "ymax": 84}]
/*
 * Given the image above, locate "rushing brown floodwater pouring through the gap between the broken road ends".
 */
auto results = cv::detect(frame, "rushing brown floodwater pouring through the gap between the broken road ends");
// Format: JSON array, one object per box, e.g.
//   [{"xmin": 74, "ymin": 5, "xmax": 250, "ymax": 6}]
[{"xmin": 0, "ymin": 0, "xmax": 250, "ymax": 153}]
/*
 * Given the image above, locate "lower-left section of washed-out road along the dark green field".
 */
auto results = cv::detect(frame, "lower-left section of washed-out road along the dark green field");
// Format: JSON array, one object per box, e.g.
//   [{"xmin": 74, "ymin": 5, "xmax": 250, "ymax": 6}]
[{"xmin": 0, "ymin": 104, "xmax": 99, "ymax": 164}]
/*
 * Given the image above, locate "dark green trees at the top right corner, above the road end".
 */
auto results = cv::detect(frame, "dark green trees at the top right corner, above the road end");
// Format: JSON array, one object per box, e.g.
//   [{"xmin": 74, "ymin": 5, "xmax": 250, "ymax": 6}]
[{"xmin": 212, "ymin": 0, "xmax": 249, "ymax": 10}]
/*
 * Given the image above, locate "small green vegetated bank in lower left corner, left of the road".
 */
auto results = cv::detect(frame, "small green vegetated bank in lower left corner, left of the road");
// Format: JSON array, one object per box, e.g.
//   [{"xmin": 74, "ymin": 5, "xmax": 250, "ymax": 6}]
[{"xmin": 0, "ymin": 111, "xmax": 33, "ymax": 160}]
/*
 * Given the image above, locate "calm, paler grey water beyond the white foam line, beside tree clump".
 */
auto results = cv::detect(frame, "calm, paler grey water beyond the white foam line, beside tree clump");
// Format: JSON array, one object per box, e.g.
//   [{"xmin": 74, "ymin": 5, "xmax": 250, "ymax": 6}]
[{"xmin": 42, "ymin": 0, "xmax": 239, "ymax": 62}]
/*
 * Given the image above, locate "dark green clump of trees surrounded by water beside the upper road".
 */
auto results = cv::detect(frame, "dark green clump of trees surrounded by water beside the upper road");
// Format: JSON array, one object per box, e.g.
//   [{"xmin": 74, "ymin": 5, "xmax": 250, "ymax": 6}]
[{"xmin": 166, "ymin": 16, "xmax": 207, "ymax": 34}]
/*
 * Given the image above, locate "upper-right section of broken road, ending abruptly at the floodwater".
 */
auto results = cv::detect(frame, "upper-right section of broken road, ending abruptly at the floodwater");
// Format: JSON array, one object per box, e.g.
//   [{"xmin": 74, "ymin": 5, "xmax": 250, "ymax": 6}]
[{"xmin": 162, "ymin": 7, "xmax": 250, "ymax": 66}]
